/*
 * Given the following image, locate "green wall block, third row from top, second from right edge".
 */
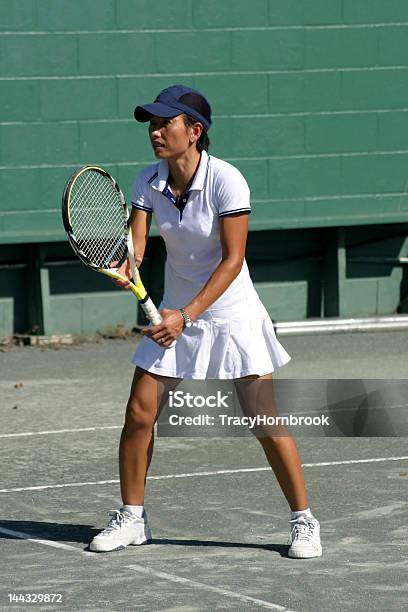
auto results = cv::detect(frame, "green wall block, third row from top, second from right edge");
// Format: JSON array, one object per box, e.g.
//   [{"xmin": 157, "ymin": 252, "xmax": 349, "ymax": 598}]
[{"xmin": 268, "ymin": 72, "xmax": 344, "ymax": 113}]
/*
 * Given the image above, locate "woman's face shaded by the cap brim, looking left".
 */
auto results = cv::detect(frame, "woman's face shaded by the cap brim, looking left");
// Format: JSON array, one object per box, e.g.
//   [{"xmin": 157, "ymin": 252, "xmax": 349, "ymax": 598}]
[{"xmin": 149, "ymin": 115, "xmax": 199, "ymax": 159}]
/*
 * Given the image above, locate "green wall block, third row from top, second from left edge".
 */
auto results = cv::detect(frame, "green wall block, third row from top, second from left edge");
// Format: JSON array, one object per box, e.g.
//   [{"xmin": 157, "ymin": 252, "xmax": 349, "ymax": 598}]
[{"xmin": 40, "ymin": 78, "xmax": 117, "ymax": 121}]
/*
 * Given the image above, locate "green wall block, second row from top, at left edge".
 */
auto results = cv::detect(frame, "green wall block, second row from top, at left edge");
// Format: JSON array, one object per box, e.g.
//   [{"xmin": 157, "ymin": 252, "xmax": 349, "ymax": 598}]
[{"xmin": 0, "ymin": 34, "xmax": 78, "ymax": 77}]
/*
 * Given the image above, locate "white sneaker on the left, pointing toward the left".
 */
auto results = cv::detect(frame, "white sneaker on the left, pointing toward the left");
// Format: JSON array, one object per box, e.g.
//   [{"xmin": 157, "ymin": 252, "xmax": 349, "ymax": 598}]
[{"xmin": 89, "ymin": 510, "xmax": 152, "ymax": 552}]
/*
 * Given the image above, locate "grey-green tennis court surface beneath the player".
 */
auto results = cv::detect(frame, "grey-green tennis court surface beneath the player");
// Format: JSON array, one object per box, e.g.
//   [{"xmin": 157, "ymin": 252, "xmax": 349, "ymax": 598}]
[{"xmin": 0, "ymin": 331, "xmax": 408, "ymax": 612}]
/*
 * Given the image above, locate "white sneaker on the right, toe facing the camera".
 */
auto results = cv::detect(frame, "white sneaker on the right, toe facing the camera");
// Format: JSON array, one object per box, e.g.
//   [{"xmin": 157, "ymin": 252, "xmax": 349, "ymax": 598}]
[{"xmin": 288, "ymin": 514, "xmax": 322, "ymax": 559}]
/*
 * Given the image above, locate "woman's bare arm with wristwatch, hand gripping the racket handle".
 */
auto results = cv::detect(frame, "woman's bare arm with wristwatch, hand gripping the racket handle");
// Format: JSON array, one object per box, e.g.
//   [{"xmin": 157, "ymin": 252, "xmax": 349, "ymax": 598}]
[{"xmin": 143, "ymin": 213, "xmax": 248, "ymax": 345}]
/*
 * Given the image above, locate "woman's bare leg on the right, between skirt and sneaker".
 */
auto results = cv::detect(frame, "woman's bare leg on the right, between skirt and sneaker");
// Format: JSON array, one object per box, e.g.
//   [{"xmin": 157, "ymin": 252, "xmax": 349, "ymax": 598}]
[{"xmin": 237, "ymin": 374, "xmax": 309, "ymax": 511}]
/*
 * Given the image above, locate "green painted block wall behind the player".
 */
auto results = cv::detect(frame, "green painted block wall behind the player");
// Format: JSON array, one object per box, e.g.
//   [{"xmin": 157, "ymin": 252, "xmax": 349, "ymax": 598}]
[{"xmin": 0, "ymin": 0, "xmax": 408, "ymax": 335}]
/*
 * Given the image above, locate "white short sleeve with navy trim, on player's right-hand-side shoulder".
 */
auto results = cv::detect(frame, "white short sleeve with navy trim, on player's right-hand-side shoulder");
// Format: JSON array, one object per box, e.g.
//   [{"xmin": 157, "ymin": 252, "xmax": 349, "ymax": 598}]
[{"xmin": 217, "ymin": 164, "xmax": 251, "ymax": 217}]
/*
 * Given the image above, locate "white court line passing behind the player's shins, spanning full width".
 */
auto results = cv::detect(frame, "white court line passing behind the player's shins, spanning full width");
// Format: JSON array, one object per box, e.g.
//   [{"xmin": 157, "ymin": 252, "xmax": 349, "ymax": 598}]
[{"xmin": 0, "ymin": 455, "xmax": 408, "ymax": 493}]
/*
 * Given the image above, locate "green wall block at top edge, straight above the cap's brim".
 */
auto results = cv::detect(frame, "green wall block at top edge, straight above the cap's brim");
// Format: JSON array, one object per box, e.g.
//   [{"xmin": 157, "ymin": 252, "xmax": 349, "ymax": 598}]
[{"xmin": 116, "ymin": 0, "xmax": 192, "ymax": 30}]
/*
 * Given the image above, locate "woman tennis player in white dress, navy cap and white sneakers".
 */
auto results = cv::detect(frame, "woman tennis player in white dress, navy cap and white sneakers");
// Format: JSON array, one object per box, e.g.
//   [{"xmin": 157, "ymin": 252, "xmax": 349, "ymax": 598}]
[{"xmin": 90, "ymin": 85, "xmax": 322, "ymax": 558}]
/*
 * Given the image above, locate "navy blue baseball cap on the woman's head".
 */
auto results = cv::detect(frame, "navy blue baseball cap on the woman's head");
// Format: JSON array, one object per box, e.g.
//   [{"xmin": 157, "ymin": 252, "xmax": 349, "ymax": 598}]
[{"xmin": 134, "ymin": 85, "xmax": 211, "ymax": 130}]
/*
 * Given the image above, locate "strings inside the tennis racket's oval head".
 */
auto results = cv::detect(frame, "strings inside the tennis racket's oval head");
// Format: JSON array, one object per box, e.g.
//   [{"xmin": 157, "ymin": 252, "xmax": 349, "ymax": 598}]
[{"xmin": 70, "ymin": 170, "xmax": 127, "ymax": 268}]
